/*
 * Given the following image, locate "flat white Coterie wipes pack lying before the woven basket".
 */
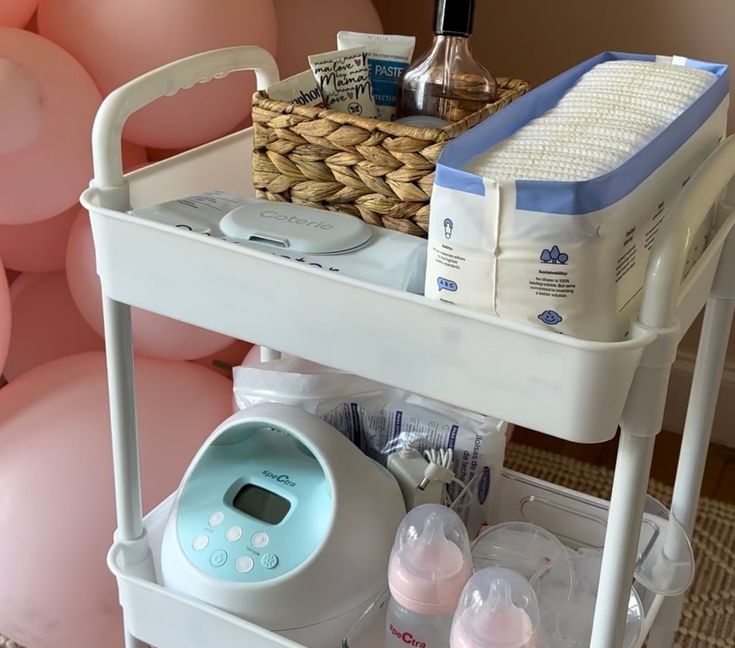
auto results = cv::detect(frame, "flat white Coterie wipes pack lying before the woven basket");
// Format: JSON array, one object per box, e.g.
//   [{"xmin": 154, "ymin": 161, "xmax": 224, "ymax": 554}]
[{"xmin": 130, "ymin": 191, "xmax": 426, "ymax": 294}]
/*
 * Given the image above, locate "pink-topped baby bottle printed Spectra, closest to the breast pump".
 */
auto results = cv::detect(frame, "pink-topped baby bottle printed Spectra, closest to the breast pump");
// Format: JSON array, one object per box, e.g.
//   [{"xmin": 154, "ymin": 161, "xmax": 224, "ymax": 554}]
[{"xmin": 385, "ymin": 504, "xmax": 472, "ymax": 648}]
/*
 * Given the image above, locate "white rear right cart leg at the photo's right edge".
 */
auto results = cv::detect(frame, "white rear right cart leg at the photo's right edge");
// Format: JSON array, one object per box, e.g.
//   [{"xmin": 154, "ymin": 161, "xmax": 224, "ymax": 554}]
[{"xmin": 648, "ymin": 298, "xmax": 735, "ymax": 648}]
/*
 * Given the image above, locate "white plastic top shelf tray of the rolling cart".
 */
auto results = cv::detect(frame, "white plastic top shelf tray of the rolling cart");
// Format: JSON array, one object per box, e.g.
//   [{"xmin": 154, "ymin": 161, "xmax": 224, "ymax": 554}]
[{"xmin": 84, "ymin": 124, "xmax": 732, "ymax": 443}]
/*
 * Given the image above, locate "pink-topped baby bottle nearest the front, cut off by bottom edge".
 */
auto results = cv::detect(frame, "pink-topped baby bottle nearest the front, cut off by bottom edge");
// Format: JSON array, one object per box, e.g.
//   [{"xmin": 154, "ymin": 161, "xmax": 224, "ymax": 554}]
[{"xmin": 449, "ymin": 567, "xmax": 539, "ymax": 648}]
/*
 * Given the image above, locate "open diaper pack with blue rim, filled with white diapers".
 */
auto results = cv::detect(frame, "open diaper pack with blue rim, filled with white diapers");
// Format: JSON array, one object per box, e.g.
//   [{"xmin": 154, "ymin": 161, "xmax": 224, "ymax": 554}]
[{"xmin": 426, "ymin": 52, "xmax": 729, "ymax": 341}]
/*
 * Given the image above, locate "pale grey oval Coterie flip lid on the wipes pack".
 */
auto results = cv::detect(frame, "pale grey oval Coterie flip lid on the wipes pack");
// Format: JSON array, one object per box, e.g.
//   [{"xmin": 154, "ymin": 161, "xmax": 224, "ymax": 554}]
[{"xmin": 220, "ymin": 198, "xmax": 373, "ymax": 254}]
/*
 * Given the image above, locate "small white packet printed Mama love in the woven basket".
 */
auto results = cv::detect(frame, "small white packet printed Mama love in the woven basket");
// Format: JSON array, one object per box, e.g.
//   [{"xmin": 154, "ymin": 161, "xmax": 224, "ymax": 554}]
[{"xmin": 309, "ymin": 47, "xmax": 378, "ymax": 117}]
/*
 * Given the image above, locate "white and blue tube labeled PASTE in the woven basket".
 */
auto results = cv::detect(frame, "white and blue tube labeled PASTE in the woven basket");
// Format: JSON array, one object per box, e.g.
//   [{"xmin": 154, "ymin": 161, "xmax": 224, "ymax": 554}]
[{"xmin": 337, "ymin": 31, "xmax": 416, "ymax": 121}]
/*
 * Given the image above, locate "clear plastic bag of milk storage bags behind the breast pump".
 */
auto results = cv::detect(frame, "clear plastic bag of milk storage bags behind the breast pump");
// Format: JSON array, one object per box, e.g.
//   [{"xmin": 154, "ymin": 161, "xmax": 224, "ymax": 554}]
[{"xmin": 234, "ymin": 357, "xmax": 507, "ymax": 537}]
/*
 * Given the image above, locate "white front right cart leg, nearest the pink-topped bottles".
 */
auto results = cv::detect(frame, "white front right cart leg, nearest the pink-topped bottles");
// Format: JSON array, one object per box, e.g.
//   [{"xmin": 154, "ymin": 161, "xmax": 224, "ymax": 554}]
[{"xmin": 590, "ymin": 366, "xmax": 669, "ymax": 648}]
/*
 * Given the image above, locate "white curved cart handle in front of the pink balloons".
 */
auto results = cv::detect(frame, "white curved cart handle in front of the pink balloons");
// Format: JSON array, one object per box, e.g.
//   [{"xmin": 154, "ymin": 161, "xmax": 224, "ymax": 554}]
[{"xmin": 92, "ymin": 45, "xmax": 278, "ymax": 210}]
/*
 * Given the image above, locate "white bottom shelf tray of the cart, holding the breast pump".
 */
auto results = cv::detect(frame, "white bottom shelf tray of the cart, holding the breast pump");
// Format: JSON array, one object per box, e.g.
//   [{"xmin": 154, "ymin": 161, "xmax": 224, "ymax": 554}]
[{"xmin": 108, "ymin": 471, "xmax": 661, "ymax": 648}]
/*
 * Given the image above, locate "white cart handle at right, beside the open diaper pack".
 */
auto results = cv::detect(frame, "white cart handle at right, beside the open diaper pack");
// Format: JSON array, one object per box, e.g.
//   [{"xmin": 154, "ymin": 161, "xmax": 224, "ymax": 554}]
[{"xmin": 638, "ymin": 136, "xmax": 735, "ymax": 329}]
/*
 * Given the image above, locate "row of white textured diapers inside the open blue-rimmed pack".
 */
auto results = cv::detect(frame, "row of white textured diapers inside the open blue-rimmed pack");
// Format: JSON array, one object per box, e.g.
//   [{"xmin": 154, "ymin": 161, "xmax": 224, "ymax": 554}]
[{"xmin": 466, "ymin": 61, "xmax": 717, "ymax": 182}]
